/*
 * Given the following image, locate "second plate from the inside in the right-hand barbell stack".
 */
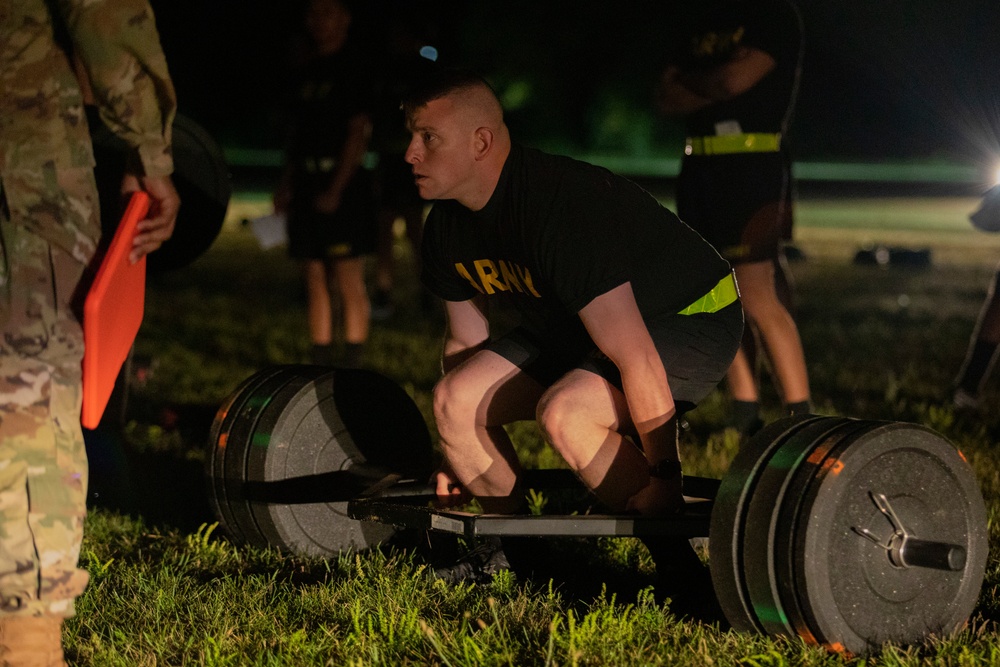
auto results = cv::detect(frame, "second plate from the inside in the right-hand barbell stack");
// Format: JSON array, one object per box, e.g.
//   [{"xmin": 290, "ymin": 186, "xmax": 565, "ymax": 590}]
[{"xmin": 743, "ymin": 417, "xmax": 850, "ymax": 635}]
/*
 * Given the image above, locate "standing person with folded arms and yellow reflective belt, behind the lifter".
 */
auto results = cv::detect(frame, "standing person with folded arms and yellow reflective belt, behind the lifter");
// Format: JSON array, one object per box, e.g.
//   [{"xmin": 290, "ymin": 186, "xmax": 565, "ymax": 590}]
[{"xmin": 657, "ymin": 0, "xmax": 811, "ymax": 434}]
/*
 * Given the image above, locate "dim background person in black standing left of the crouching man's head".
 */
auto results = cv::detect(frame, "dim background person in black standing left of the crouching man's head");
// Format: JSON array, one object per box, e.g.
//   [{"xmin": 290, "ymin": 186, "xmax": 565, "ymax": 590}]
[{"xmin": 274, "ymin": 0, "xmax": 376, "ymax": 368}]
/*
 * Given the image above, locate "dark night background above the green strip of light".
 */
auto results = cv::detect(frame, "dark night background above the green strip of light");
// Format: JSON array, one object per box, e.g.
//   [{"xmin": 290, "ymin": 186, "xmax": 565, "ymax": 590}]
[{"xmin": 146, "ymin": 0, "xmax": 1000, "ymax": 180}]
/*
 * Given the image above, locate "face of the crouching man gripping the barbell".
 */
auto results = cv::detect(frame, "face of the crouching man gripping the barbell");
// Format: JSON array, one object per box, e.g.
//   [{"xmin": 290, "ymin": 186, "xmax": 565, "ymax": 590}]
[{"xmin": 406, "ymin": 97, "xmax": 476, "ymax": 203}]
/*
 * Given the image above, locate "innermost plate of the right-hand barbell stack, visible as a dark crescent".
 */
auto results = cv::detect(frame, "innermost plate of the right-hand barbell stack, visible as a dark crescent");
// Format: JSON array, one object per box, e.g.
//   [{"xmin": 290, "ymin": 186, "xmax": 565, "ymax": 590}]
[{"xmin": 708, "ymin": 415, "xmax": 823, "ymax": 632}]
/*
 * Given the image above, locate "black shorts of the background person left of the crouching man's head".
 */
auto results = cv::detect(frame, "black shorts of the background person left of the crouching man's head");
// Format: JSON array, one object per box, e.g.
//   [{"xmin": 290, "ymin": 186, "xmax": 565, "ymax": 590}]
[{"xmin": 288, "ymin": 170, "xmax": 378, "ymax": 259}]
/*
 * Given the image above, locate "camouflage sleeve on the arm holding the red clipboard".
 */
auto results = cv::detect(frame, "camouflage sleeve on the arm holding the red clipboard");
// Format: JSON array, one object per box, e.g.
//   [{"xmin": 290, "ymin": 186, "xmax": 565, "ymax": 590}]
[{"xmin": 59, "ymin": 0, "xmax": 177, "ymax": 176}]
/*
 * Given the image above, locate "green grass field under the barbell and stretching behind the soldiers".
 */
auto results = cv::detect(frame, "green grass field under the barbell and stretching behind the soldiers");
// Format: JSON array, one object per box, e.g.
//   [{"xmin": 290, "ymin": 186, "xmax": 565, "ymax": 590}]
[{"xmin": 67, "ymin": 190, "xmax": 1000, "ymax": 666}]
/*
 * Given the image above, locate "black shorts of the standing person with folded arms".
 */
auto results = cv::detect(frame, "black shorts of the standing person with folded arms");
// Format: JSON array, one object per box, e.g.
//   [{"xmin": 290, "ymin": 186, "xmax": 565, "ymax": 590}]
[{"xmin": 677, "ymin": 153, "xmax": 792, "ymax": 264}]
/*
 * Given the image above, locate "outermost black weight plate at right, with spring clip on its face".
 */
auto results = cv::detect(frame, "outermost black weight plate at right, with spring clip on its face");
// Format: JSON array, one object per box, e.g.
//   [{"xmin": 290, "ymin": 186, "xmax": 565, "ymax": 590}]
[{"xmin": 793, "ymin": 422, "xmax": 988, "ymax": 655}]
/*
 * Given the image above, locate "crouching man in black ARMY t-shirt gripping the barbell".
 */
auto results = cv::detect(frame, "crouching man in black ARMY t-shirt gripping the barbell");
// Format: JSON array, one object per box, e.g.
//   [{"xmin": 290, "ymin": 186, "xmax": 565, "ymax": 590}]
[{"xmin": 404, "ymin": 71, "xmax": 743, "ymax": 579}]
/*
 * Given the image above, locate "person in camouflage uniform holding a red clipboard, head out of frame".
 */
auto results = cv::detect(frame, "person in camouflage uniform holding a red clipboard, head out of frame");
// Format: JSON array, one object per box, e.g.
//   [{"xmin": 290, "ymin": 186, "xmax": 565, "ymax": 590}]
[{"xmin": 0, "ymin": 0, "xmax": 180, "ymax": 665}]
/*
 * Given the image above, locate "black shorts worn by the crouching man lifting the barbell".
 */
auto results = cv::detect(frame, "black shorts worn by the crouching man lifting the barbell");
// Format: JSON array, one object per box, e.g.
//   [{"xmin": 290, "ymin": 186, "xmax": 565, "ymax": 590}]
[{"xmin": 487, "ymin": 301, "xmax": 743, "ymax": 414}]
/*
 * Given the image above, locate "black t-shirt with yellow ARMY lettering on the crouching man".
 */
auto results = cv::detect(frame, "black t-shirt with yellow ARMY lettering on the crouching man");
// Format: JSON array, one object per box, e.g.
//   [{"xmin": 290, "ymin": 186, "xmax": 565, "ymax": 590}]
[{"xmin": 422, "ymin": 145, "xmax": 730, "ymax": 342}]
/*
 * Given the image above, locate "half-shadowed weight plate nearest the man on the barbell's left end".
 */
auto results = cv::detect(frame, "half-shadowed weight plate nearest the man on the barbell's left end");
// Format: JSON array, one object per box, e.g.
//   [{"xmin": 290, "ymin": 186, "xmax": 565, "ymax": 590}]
[{"xmin": 247, "ymin": 369, "xmax": 432, "ymax": 556}]
